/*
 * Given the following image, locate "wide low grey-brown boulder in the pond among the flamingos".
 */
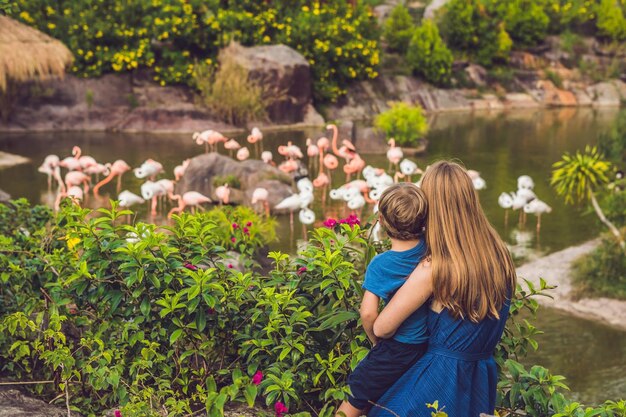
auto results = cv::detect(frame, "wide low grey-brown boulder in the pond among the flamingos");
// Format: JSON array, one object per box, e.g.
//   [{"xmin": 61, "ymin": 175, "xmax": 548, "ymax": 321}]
[{"xmin": 176, "ymin": 153, "xmax": 293, "ymax": 207}]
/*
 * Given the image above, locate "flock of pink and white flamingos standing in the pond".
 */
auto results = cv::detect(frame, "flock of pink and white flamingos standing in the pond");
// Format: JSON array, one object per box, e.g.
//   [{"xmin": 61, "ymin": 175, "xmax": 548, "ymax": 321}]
[{"xmin": 38, "ymin": 124, "xmax": 551, "ymax": 234}]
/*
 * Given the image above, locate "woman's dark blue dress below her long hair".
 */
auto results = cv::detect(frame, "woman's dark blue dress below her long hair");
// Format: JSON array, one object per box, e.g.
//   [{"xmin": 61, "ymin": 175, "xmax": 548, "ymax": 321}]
[{"xmin": 368, "ymin": 303, "xmax": 509, "ymax": 417}]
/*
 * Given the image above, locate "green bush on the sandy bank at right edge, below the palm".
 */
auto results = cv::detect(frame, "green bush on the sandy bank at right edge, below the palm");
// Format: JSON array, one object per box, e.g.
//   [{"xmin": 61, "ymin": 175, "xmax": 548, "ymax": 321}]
[{"xmin": 573, "ymin": 236, "xmax": 626, "ymax": 300}]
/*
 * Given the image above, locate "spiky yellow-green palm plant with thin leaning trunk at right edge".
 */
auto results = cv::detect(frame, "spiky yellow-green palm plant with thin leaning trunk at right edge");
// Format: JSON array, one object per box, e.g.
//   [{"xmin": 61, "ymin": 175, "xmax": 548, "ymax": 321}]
[{"xmin": 550, "ymin": 146, "xmax": 626, "ymax": 251}]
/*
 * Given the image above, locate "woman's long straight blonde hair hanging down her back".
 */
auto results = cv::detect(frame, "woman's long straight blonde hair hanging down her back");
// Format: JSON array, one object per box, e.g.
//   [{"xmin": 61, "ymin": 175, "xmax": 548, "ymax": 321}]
[{"xmin": 421, "ymin": 161, "xmax": 516, "ymax": 322}]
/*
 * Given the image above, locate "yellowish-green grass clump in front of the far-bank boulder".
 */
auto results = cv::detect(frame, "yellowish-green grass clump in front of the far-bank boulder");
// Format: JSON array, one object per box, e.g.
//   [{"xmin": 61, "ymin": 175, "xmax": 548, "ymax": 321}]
[{"xmin": 194, "ymin": 58, "xmax": 274, "ymax": 126}]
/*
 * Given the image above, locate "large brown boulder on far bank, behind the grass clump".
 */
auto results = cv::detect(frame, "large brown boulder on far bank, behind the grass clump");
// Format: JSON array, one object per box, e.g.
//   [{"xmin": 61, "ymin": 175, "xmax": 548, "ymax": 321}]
[{"xmin": 220, "ymin": 43, "xmax": 312, "ymax": 123}]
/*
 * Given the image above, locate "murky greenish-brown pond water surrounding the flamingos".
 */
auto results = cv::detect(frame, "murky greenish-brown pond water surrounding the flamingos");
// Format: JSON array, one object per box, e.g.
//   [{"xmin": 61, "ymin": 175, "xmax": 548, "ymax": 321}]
[{"xmin": 0, "ymin": 109, "xmax": 626, "ymax": 402}]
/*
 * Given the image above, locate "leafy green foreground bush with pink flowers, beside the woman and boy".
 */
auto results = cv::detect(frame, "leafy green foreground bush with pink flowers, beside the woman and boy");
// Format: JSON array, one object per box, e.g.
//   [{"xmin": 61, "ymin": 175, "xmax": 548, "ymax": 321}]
[{"xmin": 0, "ymin": 200, "xmax": 626, "ymax": 417}]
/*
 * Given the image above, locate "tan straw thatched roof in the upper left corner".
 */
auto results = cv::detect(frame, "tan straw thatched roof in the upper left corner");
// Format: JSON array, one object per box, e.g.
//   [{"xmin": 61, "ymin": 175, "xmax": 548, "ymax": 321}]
[{"xmin": 0, "ymin": 15, "xmax": 73, "ymax": 93}]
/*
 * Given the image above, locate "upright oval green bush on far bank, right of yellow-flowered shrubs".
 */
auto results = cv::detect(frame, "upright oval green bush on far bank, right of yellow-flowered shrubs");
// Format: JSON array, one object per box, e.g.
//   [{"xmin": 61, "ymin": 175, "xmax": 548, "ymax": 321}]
[{"xmin": 407, "ymin": 20, "xmax": 453, "ymax": 86}]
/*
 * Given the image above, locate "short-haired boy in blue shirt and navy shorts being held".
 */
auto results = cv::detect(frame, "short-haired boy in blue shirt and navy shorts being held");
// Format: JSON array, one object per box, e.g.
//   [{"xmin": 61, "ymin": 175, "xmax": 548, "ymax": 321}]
[{"xmin": 335, "ymin": 183, "xmax": 428, "ymax": 417}]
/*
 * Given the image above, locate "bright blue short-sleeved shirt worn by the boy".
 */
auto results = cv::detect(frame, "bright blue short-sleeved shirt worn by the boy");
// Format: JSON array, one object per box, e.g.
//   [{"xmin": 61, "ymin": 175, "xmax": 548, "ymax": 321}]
[{"xmin": 363, "ymin": 239, "xmax": 428, "ymax": 344}]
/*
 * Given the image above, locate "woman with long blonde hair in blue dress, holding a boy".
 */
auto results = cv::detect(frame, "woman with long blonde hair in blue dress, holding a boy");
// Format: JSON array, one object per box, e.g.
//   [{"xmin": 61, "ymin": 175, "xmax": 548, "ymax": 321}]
[{"xmin": 368, "ymin": 161, "xmax": 516, "ymax": 417}]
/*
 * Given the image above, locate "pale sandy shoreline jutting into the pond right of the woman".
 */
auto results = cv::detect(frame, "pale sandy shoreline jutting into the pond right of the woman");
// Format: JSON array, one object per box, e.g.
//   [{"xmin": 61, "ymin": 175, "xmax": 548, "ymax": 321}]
[{"xmin": 517, "ymin": 239, "xmax": 626, "ymax": 331}]
